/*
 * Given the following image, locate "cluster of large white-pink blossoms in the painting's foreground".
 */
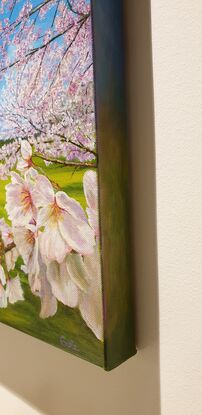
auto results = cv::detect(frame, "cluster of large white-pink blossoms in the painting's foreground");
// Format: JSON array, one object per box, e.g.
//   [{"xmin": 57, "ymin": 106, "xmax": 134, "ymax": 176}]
[{"xmin": 0, "ymin": 140, "xmax": 103, "ymax": 340}]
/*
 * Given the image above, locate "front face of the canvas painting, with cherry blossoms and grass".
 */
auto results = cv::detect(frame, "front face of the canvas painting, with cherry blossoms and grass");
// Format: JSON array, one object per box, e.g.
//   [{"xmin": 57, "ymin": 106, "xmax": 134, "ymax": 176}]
[{"xmin": 0, "ymin": 0, "xmax": 103, "ymax": 363}]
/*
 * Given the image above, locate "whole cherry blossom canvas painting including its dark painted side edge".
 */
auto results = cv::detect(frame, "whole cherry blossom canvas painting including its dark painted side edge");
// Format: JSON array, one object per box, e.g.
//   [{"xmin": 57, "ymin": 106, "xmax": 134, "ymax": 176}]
[{"xmin": 0, "ymin": 0, "xmax": 135, "ymax": 370}]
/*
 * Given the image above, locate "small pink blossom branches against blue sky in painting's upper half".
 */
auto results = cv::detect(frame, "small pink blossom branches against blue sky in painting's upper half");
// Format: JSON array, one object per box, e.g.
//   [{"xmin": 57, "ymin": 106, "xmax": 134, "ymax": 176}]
[{"xmin": 0, "ymin": 0, "xmax": 96, "ymax": 179}]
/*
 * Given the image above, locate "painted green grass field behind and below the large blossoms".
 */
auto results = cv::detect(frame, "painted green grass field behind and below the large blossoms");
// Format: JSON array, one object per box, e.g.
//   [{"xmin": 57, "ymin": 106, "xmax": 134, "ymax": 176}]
[{"xmin": 0, "ymin": 159, "xmax": 104, "ymax": 366}]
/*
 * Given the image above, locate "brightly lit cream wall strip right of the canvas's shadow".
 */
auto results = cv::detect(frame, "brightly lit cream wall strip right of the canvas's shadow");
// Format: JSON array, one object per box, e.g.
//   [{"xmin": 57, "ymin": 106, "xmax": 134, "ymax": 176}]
[{"xmin": 151, "ymin": 0, "xmax": 202, "ymax": 415}]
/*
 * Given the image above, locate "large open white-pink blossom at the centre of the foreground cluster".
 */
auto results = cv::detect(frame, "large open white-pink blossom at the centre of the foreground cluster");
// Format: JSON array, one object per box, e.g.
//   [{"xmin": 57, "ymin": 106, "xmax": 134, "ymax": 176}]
[{"xmin": 32, "ymin": 175, "xmax": 95, "ymax": 263}]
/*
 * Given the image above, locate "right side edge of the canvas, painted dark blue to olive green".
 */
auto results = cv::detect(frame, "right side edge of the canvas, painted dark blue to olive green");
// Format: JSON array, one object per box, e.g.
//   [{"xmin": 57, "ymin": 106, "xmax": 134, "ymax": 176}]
[{"xmin": 92, "ymin": 0, "xmax": 136, "ymax": 370}]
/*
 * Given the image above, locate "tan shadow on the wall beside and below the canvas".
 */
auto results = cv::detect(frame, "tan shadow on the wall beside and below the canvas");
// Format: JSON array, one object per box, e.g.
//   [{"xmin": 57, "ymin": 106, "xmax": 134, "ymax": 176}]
[{"xmin": 0, "ymin": 0, "xmax": 160, "ymax": 415}]
